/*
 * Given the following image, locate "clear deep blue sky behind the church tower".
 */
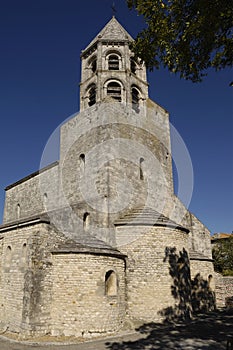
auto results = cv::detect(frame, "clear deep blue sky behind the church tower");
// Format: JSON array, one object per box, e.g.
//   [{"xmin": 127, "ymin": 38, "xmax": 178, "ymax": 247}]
[{"xmin": 0, "ymin": 0, "xmax": 233, "ymax": 233}]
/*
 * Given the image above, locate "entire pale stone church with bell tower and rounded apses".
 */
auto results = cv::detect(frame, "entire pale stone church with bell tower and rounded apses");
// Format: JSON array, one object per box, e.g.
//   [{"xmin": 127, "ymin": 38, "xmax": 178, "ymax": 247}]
[{"xmin": 0, "ymin": 17, "xmax": 214, "ymax": 337}]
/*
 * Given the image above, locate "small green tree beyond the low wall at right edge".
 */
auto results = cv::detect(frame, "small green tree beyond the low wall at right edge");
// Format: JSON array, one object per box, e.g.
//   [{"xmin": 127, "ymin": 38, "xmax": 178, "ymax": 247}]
[{"xmin": 213, "ymin": 234, "xmax": 233, "ymax": 276}]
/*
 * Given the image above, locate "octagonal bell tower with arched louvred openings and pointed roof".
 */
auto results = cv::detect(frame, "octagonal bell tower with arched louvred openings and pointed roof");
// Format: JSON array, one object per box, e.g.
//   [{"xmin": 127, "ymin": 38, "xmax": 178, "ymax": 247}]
[{"xmin": 80, "ymin": 17, "xmax": 148, "ymax": 111}]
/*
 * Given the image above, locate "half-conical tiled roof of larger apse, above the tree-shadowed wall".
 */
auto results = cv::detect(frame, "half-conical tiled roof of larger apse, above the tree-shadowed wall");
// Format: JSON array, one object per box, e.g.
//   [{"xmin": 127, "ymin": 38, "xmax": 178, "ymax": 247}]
[{"xmin": 114, "ymin": 207, "xmax": 189, "ymax": 233}]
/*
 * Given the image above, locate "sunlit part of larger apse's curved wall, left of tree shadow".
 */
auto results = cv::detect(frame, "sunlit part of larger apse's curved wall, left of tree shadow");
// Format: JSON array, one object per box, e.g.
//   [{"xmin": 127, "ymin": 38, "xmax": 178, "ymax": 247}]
[{"xmin": 116, "ymin": 225, "xmax": 188, "ymax": 322}]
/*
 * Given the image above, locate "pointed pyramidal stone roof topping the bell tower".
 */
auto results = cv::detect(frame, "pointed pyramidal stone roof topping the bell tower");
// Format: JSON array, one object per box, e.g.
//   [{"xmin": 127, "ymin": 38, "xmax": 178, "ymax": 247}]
[{"xmin": 84, "ymin": 16, "xmax": 134, "ymax": 51}]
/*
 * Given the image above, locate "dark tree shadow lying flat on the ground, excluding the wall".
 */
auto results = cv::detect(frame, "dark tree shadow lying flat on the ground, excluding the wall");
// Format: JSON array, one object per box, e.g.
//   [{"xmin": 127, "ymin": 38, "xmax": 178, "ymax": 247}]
[{"xmin": 105, "ymin": 310, "xmax": 233, "ymax": 350}]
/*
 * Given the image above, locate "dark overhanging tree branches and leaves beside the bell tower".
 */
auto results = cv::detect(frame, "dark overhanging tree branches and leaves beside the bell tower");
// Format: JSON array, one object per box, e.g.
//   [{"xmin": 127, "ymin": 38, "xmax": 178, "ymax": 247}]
[{"xmin": 127, "ymin": 0, "xmax": 233, "ymax": 82}]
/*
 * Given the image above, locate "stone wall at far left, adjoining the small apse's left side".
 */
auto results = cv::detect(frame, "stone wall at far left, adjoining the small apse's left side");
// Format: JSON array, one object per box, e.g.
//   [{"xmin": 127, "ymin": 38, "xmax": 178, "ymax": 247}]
[{"xmin": 1, "ymin": 220, "xmax": 64, "ymax": 334}]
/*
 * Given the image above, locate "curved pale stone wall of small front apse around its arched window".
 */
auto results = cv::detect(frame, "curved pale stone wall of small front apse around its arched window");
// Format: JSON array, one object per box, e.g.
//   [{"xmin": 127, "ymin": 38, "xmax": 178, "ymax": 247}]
[{"xmin": 51, "ymin": 254, "xmax": 125, "ymax": 336}]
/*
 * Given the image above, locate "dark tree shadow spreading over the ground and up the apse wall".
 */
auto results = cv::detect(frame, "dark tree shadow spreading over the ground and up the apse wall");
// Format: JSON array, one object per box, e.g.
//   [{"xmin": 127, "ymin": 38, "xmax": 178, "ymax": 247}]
[{"xmin": 105, "ymin": 247, "xmax": 233, "ymax": 350}]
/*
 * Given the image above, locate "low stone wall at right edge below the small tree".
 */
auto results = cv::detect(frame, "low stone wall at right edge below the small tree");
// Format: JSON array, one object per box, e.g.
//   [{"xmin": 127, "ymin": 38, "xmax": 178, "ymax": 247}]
[{"xmin": 215, "ymin": 273, "xmax": 233, "ymax": 307}]
